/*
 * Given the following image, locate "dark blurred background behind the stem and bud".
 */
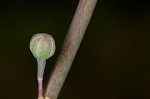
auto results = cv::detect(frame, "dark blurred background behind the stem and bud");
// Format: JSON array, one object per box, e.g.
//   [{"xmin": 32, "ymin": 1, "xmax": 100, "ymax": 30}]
[{"xmin": 0, "ymin": 0, "xmax": 150, "ymax": 99}]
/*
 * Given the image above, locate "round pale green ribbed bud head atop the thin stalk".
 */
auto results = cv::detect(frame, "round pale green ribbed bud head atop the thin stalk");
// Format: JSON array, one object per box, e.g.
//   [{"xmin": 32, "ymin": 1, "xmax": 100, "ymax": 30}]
[{"xmin": 30, "ymin": 33, "xmax": 56, "ymax": 60}]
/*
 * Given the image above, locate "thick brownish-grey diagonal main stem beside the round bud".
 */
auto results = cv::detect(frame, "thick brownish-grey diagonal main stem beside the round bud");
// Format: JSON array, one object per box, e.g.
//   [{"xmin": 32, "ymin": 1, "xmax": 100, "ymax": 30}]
[{"xmin": 45, "ymin": 0, "xmax": 97, "ymax": 99}]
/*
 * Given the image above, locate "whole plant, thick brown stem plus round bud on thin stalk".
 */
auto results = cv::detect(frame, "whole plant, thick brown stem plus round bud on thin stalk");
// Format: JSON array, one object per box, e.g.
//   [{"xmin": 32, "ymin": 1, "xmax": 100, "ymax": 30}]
[{"xmin": 30, "ymin": 0, "xmax": 97, "ymax": 99}]
